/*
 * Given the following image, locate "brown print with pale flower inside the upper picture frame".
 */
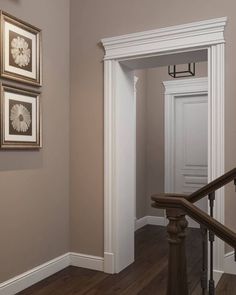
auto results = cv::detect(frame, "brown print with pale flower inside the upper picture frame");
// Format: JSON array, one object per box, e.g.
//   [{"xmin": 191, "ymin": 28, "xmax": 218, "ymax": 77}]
[{"xmin": 9, "ymin": 31, "xmax": 32, "ymax": 72}]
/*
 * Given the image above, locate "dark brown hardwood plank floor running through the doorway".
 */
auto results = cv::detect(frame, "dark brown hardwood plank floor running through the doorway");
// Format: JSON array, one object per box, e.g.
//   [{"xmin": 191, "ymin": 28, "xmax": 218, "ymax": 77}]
[{"xmin": 18, "ymin": 225, "xmax": 232, "ymax": 295}]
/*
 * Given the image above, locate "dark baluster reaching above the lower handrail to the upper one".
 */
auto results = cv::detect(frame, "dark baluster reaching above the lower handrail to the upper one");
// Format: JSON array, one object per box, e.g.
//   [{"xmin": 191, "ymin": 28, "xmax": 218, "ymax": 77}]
[{"xmin": 208, "ymin": 192, "xmax": 215, "ymax": 295}]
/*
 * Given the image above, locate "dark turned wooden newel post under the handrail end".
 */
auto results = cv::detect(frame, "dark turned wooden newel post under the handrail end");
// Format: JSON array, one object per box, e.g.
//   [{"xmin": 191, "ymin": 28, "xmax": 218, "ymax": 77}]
[{"xmin": 166, "ymin": 209, "xmax": 189, "ymax": 295}]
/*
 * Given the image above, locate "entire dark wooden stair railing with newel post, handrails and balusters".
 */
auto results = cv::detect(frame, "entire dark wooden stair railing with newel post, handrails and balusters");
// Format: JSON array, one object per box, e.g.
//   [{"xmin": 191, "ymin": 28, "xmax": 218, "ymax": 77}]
[{"xmin": 151, "ymin": 168, "xmax": 236, "ymax": 295}]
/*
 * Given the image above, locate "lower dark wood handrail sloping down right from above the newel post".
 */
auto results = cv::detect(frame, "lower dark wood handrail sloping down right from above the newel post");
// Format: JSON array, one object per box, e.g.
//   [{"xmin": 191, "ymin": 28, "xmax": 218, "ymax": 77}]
[{"xmin": 152, "ymin": 195, "xmax": 236, "ymax": 248}]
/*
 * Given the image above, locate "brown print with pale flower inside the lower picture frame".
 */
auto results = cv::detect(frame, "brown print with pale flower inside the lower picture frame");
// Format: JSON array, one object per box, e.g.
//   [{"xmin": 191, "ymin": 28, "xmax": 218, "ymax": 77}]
[{"xmin": 9, "ymin": 99, "xmax": 32, "ymax": 136}]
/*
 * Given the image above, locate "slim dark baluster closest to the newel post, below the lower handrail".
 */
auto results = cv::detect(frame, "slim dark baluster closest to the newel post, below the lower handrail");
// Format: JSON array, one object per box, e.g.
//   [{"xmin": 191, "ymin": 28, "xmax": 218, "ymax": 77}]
[{"xmin": 201, "ymin": 224, "xmax": 208, "ymax": 295}]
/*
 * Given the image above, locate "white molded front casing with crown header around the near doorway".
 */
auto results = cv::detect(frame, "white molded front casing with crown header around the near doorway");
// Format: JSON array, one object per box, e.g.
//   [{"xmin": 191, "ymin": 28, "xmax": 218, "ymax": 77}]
[{"xmin": 101, "ymin": 17, "xmax": 227, "ymax": 282}]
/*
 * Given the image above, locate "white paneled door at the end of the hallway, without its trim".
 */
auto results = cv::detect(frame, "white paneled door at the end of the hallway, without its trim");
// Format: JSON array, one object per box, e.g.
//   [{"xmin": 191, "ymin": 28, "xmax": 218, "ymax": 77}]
[{"xmin": 174, "ymin": 94, "xmax": 208, "ymax": 227}]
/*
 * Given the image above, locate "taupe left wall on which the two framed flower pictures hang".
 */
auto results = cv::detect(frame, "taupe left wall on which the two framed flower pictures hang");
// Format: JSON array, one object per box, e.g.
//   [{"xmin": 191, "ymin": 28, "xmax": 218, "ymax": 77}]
[{"xmin": 0, "ymin": 0, "xmax": 69, "ymax": 282}]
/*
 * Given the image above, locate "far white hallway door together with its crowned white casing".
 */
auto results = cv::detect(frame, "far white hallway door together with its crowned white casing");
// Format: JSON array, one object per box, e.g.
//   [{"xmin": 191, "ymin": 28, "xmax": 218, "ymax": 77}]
[{"xmin": 163, "ymin": 78, "xmax": 208, "ymax": 227}]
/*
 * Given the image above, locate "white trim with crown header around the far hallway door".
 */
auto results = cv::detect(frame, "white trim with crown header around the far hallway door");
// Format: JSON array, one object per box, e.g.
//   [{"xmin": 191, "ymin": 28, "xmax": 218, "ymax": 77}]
[{"xmin": 163, "ymin": 78, "xmax": 208, "ymax": 192}]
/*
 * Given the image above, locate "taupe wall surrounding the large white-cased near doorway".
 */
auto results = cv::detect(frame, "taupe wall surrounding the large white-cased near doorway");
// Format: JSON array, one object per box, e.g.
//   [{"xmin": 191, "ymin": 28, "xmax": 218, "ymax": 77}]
[{"xmin": 70, "ymin": 0, "xmax": 236, "ymax": 256}]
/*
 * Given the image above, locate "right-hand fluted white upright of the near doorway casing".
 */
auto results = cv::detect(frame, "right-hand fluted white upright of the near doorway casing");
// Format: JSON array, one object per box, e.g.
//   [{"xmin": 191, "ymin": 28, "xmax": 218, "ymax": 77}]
[{"xmin": 208, "ymin": 44, "xmax": 225, "ymax": 280}]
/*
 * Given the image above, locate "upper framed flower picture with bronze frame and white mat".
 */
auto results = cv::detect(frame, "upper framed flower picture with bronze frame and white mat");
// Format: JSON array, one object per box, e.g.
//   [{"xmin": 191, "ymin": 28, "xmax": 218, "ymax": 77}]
[{"xmin": 1, "ymin": 11, "xmax": 42, "ymax": 86}]
